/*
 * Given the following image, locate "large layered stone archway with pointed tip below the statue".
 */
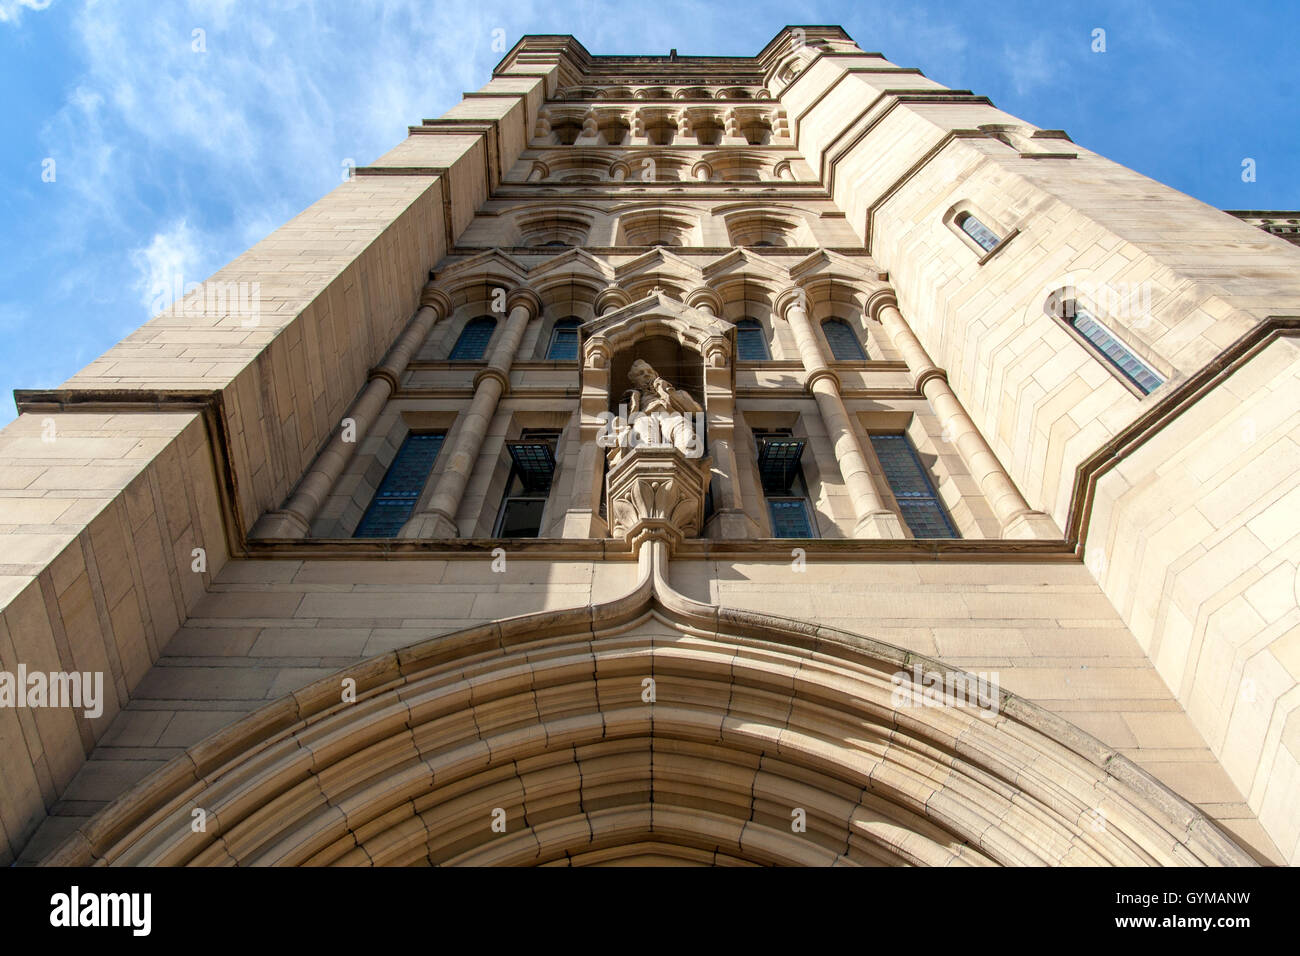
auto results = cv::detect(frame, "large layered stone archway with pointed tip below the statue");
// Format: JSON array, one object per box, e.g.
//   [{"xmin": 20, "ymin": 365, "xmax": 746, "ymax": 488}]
[{"xmin": 47, "ymin": 540, "xmax": 1253, "ymax": 865}]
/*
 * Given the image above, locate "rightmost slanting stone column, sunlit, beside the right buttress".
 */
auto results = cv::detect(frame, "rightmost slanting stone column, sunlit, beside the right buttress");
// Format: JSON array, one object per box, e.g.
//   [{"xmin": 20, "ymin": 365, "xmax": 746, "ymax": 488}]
[{"xmin": 867, "ymin": 290, "xmax": 1061, "ymax": 538}]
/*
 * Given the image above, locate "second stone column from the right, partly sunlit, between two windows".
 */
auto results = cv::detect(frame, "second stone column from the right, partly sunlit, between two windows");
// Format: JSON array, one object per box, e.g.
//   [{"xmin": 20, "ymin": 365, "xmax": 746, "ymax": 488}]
[{"xmin": 776, "ymin": 287, "xmax": 906, "ymax": 538}]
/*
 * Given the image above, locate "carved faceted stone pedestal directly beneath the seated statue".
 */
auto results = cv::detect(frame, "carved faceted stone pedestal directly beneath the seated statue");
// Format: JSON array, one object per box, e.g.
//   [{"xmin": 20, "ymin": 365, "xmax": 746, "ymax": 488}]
[{"xmin": 606, "ymin": 445, "xmax": 712, "ymax": 549}]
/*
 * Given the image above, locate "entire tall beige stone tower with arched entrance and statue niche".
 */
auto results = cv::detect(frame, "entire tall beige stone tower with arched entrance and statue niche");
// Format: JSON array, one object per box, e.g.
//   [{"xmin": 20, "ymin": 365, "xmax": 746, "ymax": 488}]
[{"xmin": 0, "ymin": 26, "xmax": 1300, "ymax": 865}]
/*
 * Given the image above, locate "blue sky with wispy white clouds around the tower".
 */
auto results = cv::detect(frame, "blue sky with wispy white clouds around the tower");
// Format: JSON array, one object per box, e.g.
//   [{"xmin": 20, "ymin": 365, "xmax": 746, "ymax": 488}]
[{"xmin": 0, "ymin": 0, "xmax": 1300, "ymax": 423}]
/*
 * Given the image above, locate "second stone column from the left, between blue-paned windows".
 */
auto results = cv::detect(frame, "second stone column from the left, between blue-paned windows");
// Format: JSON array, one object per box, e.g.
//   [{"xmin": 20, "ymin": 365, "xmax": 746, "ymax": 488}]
[{"xmin": 399, "ymin": 287, "xmax": 542, "ymax": 537}]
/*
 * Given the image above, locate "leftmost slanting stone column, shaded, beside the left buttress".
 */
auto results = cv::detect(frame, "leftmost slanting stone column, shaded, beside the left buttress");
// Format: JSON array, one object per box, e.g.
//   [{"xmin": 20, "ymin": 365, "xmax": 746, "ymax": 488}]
[{"xmin": 248, "ymin": 285, "xmax": 451, "ymax": 538}]
